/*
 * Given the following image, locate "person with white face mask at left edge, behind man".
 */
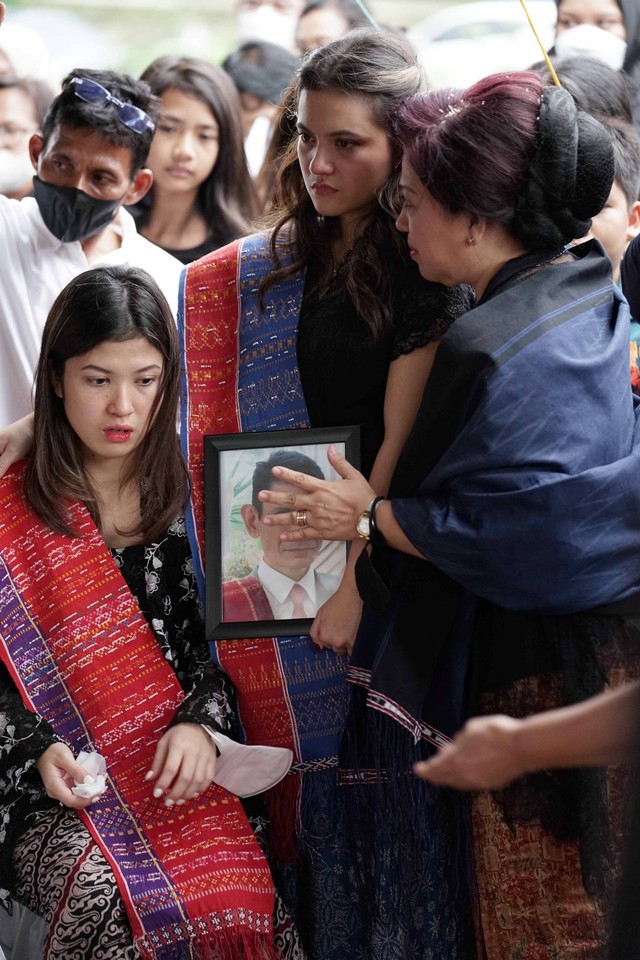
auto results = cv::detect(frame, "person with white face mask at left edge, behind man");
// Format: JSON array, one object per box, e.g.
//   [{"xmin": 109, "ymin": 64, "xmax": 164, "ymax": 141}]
[{"xmin": 0, "ymin": 77, "xmax": 54, "ymax": 200}]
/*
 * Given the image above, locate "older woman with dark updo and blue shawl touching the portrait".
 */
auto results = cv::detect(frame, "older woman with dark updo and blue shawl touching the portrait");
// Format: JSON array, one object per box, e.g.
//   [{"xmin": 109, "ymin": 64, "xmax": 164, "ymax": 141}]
[{"xmin": 259, "ymin": 72, "xmax": 640, "ymax": 960}]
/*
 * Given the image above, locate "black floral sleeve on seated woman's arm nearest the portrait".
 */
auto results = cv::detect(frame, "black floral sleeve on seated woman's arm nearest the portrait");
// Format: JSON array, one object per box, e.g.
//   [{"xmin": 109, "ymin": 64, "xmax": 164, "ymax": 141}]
[{"xmin": 112, "ymin": 519, "xmax": 234, "ymax": 732}]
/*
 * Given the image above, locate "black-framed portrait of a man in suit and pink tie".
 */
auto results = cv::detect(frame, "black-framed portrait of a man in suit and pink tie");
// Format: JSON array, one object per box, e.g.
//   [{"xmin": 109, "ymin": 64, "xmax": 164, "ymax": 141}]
[{"xmin": 204, "ymin": 426, "xmax": 360, "ymax": 640}]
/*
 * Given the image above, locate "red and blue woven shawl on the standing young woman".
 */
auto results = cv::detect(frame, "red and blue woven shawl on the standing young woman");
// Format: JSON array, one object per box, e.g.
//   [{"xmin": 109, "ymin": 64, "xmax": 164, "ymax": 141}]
[{"xmin": 178, "ymin": 234, "xmax": 347, "ymax": 856}]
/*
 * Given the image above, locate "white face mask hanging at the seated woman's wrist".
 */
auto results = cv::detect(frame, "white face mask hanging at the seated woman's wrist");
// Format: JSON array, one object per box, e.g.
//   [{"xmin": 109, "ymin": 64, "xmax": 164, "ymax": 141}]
[{"xmin": 204, "ymin": 726, "xmax": 293, "ymax": 797}]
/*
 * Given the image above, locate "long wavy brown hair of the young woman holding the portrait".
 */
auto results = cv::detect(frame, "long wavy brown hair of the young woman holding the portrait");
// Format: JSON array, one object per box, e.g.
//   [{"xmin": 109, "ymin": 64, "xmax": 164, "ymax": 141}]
[{"xmin": 261, "ymin": 30, "xmax": 425, "ymax": 336}]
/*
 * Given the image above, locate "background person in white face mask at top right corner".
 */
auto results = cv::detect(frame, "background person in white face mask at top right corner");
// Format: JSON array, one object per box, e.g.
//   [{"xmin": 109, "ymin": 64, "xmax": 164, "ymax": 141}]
[{"xmin": 552, "ymin": 0, "xmax": 640, "ymax": 128}]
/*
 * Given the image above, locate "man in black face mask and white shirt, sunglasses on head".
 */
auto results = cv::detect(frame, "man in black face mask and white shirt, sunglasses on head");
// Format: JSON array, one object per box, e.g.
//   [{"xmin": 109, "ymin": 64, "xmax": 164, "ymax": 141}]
[{"xmin": 0, "ymin": 3, "xmax": 182, "ymax": 426}]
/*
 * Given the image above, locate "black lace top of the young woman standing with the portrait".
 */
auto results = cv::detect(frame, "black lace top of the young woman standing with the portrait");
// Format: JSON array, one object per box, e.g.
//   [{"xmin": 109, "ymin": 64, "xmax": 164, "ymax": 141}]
[{"xmin": 298, "ymin": 261, "xmax": 470, "ymax": 476}]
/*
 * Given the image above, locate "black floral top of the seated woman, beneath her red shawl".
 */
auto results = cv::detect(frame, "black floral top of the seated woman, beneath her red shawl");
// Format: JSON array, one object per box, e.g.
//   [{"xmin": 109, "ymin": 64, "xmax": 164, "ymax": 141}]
[{"xmin": 0, "ymin": 519, "xmax": 233, "ymax": 902}]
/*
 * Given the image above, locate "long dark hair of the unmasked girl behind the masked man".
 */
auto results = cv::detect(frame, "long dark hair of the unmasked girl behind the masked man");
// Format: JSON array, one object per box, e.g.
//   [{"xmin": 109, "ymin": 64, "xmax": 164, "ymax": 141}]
[{"xmin": 140, "ymin": 56, "xmax": 258, "ymax": 246}]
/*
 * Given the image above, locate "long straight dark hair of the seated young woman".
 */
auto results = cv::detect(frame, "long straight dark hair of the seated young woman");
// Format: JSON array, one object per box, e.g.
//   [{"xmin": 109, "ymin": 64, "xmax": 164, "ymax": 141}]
[{"xmin": 24, "ymin": 266, "xmax": 189, "ymax": 543}]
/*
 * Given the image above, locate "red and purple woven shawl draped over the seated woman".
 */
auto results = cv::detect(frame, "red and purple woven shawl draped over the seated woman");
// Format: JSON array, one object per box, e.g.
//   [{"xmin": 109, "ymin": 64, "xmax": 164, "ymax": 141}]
[{"xmin": 0, "ymin": 469, "xmax": 275, "ymax": 960}]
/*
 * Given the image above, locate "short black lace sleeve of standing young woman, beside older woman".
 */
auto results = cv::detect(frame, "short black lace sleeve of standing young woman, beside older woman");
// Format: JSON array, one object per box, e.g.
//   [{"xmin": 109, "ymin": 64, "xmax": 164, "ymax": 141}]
[{"xmin": 391, "ymin": 264, "xmax": 474, "ymax": 360}]
